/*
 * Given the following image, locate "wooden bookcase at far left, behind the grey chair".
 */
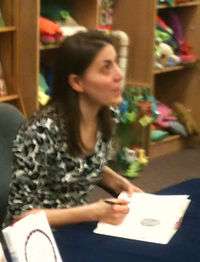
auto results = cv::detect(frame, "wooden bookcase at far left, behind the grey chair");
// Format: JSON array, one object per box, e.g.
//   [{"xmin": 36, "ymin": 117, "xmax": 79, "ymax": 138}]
[{"xmin": 0, "ymin": 0, "xmax": 39, "ymax": 115}]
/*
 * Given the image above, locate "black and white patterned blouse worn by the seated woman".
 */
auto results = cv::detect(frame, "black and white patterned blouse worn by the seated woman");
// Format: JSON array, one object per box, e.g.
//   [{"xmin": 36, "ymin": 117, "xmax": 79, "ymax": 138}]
[{"xmin": 7, "ymin": 106, "xmax": 109, "ymax": 224}]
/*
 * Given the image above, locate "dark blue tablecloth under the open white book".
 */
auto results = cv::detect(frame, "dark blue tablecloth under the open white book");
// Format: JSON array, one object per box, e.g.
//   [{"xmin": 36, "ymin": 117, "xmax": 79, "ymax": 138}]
[{"xmin": 54, "ymin": 179, "xmax": 200, "ymax": 262}]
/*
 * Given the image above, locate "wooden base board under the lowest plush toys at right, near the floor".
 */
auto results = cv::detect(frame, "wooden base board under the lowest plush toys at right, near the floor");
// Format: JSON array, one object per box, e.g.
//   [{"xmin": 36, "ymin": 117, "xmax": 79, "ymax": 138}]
[{"xmin": 149, "ymin": 135, "xmax": 186, "ymax": 158}]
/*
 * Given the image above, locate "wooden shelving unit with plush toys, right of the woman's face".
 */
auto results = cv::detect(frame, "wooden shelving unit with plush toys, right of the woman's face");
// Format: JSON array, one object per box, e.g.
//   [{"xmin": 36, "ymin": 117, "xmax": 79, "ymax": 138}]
[{"xmin": 114, "ymin": 0, "xmax": 200, "ymax": 157}]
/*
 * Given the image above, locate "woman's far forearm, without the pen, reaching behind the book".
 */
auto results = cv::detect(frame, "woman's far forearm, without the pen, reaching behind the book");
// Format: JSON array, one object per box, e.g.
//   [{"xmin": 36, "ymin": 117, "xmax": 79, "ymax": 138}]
[{"xmin": 102, "ymin": 166, "xmax": 142, "ymax": 195}]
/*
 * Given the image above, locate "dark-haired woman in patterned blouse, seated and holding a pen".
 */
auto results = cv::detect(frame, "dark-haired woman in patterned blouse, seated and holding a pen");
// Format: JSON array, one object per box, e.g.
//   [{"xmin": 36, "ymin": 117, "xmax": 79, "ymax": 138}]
[{"xmin": 4, "ymin": 31, "xmax": 140, "ymax": 227}]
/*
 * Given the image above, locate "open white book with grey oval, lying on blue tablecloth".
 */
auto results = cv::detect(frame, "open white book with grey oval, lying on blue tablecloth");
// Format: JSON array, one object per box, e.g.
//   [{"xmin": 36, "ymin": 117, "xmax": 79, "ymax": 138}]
[{"xmin": 94, "ymin": 193, "xmax": 191, "ymax": 244}]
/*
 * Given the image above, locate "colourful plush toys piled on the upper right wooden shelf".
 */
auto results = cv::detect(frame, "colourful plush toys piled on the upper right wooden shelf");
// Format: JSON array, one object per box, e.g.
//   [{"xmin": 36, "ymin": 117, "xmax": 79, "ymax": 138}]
[{"xmin": 155, "ymin": 10, "xmax": 197, "ymax": 69}]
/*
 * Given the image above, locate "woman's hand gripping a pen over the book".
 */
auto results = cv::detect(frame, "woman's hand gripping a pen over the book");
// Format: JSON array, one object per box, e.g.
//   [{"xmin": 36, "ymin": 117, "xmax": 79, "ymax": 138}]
[{"xmin": 93, "ymin": 198, "xmax": 129, "ymax": 225}]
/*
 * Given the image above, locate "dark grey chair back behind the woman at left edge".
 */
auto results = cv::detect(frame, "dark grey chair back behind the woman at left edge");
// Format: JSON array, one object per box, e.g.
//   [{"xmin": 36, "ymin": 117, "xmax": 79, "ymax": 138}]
[{"xmin": 0, "ymin": 103, "xmax": 24, "ymax": 226}]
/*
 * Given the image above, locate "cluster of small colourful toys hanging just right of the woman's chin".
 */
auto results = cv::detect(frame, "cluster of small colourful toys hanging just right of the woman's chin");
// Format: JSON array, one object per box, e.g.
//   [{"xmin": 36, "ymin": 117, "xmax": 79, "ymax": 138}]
[{"xmin": 108, "ymin": 87, "xmax": 155, "ymax": 178}]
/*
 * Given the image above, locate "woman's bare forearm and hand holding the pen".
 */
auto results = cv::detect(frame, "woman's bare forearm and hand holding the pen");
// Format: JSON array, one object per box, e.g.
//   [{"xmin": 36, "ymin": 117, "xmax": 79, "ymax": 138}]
[{"xmin": 13, "ymin": 199, "xmax": 129, "ymax": 227}]
